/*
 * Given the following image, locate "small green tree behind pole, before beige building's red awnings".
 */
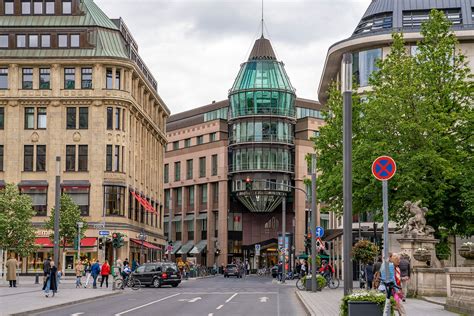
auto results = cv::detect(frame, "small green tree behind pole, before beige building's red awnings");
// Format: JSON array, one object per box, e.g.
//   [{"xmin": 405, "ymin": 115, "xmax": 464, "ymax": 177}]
[{"xmin": 46, "ymin": 194, "xmax": 87, "ymax": 251}]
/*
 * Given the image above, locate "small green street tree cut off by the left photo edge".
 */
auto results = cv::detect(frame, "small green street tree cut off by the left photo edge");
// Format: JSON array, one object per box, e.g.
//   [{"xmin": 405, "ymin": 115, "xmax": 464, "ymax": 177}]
[{"xmin": 0, "ymin": 184, "xmax": 36, "ymax": 256}]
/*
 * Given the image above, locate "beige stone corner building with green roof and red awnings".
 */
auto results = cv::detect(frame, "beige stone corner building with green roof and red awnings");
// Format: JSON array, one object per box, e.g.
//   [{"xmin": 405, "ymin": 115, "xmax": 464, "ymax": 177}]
[{"xmin": 0, "ymin": 0, "xmax": 170, "ymax": 273}]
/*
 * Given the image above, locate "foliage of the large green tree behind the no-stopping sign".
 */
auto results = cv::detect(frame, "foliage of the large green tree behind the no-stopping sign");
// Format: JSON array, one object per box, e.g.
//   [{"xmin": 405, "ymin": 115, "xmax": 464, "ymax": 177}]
[{"xmin": 315, "ymin": 10, "xmax": 474, "ymax": 235}]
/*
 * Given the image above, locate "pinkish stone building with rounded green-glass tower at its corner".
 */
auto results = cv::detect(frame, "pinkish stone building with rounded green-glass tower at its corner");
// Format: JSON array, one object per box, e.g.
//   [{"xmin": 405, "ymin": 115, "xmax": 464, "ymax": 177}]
[{"xmin": 164, "ymin": 36, "xmax": 323, "ymax": 268}]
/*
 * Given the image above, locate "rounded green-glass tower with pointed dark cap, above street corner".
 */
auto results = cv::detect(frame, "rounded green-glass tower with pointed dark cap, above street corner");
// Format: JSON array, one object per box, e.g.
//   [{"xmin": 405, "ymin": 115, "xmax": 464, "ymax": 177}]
[{"xmin": 229, "ymin": 35, "xmax": 296, "ymax": 212}]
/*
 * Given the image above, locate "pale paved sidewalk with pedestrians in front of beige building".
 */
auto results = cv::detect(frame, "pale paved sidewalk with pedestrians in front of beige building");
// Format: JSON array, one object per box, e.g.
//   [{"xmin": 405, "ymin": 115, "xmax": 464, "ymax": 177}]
[{"xmin": 0, "ymin": 276, "xmax": 122, "ymax": 316}]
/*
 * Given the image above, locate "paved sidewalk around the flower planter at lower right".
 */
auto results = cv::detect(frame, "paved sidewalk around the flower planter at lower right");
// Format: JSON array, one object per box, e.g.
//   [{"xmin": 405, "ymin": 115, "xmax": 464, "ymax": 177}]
[{"xmin": 296, "ymin": 287, "xmax": 457, "ymax": 316}]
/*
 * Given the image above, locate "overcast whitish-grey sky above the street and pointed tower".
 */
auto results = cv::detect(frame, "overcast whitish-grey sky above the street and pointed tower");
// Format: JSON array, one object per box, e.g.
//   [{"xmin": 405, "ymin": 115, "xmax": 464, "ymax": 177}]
[{"xmin": 95, "ymin": 0, "xmax": 371, "ymax": 114}]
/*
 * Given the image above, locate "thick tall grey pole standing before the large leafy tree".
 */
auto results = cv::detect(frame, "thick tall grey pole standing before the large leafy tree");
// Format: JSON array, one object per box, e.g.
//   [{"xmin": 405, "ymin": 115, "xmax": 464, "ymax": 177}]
[{"xmin": 342, "ymin": 53, "xmax": 352, "ymax": 295}]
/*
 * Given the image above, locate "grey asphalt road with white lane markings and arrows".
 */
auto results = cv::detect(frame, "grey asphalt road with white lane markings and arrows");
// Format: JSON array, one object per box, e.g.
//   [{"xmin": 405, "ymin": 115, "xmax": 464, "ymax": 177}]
[{"xmin": 36, "ymin": 276, "xmax": 306, "ymax": 316}]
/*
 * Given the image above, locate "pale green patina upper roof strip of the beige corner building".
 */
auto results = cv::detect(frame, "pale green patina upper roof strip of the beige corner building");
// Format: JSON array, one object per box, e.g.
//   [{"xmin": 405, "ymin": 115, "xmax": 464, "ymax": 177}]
[{"xmin": 0, "ymin": 0, "xmax": 117, "ymax": 30}]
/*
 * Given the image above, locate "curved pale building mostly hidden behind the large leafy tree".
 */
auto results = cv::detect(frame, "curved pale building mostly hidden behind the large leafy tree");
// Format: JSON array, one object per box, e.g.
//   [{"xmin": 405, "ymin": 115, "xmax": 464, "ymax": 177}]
[{"xmin": 318, "ymin": 0, "xmax": 474, "ymax": 278}]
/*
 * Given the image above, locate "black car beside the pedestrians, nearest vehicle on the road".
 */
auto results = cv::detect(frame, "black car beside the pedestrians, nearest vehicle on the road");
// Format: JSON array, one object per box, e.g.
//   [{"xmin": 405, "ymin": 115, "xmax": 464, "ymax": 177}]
[{"xmin": 133, "ymin": 262, "xmax": 181, "ymax": 287}]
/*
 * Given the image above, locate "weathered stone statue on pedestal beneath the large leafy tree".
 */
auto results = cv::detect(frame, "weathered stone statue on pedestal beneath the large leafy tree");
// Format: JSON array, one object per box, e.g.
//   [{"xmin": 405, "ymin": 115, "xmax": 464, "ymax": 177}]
[{"xmin": 401, "ymin": 201, "xmax": 434, "ymax": 238}]
